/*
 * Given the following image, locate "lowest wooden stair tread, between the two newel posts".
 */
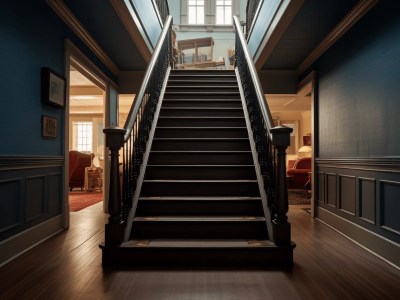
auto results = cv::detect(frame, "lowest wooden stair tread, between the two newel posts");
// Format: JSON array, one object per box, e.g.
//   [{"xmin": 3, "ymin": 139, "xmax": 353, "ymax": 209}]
[{"xmin": 121, "ymin": 239, "xmax": 276, "ymax": 248}]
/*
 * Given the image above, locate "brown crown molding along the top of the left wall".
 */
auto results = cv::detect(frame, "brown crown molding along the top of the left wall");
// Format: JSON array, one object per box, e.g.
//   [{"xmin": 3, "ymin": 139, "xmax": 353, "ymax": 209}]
[{"xmin": 46, "ymin": 0, "xmax": 120, "ymax": 75}]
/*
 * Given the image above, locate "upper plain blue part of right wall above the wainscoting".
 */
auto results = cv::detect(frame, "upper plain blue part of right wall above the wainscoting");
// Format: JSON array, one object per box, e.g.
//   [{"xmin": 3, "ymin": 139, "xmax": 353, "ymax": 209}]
[{"xmin": 314, "ymin": 1, "xmax": 400, "ymax": 157}]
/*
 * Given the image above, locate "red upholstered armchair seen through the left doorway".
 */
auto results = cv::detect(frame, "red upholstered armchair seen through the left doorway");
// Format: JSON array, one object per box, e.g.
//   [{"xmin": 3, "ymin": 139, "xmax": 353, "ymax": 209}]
[{"xmin": 69, "ymin": 150, "xmax": 94, "ymax": 191}]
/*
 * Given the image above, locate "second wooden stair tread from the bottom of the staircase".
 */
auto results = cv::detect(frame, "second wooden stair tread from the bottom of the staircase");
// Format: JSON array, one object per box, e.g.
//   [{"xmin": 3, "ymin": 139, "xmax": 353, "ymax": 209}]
[{"xmin": 134, "ymin": 216, "xmax": 265, "ymax": 222}]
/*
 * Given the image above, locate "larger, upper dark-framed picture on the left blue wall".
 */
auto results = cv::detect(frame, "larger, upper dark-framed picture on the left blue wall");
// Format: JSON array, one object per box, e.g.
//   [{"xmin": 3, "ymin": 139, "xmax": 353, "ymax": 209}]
[{"xmin": 42, "ymin": 68, "xmax": 66, "ymax": 108}]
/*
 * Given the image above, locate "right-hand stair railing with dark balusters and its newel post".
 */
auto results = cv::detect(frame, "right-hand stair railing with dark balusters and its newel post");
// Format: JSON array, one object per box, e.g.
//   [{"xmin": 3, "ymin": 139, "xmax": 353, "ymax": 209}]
[{"xmin": 233, "ymin": 16, "xmax": 293, "ymax": 245}]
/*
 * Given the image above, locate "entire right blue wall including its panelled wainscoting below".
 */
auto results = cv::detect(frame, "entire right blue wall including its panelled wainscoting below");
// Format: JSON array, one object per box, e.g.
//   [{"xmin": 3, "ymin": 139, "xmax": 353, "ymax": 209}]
[{"xmin": 312, "ymin": 1, "xmax": 400, "ymax": 255}]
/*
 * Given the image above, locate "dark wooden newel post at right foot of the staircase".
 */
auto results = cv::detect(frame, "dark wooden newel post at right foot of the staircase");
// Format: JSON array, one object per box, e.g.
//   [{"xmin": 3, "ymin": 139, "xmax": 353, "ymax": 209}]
[{"xmin": 271, "ymin": 126, "xmax": 293, "ymax": 246}]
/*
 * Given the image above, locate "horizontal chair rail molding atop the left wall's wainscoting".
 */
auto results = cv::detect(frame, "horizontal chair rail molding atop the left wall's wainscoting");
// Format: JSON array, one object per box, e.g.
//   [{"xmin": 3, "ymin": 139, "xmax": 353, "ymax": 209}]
[{"xmin": 0, "ymin": 155, "xmax": 64, "ymax": 171}]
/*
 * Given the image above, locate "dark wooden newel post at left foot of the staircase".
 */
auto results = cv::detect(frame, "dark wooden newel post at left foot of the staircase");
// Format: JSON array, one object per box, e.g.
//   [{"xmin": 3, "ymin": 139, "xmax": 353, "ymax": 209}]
[{"xmin": 103, "ymin": 128, "xmax": 126, "ymax": 246}]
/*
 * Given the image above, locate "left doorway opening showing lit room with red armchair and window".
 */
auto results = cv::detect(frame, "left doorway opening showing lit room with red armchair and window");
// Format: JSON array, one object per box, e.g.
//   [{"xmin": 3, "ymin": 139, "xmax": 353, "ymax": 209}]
[{"xmin": 68, "ymin": 61, "xmax": 105, "ymax": 212}]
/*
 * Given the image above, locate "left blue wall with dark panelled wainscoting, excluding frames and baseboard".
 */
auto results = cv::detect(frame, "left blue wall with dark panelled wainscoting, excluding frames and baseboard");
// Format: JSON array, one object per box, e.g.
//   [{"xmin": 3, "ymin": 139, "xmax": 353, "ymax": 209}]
[{"xmin": 0, "ymin": 0, "xmax": 115, "ymax": 244}]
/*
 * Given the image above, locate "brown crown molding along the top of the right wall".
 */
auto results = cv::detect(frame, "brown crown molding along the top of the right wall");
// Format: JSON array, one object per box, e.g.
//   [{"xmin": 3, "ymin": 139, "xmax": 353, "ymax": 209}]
[{"xmin": 297, "ymin": 0, "xmax": 379, "ymax": 74}]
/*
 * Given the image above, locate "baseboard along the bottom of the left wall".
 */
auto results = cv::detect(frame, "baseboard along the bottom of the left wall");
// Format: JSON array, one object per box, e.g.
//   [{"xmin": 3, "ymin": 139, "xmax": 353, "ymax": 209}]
[{"xmin": 0, "ymin": 215, "xmax": 64, "ymax": 267}]
